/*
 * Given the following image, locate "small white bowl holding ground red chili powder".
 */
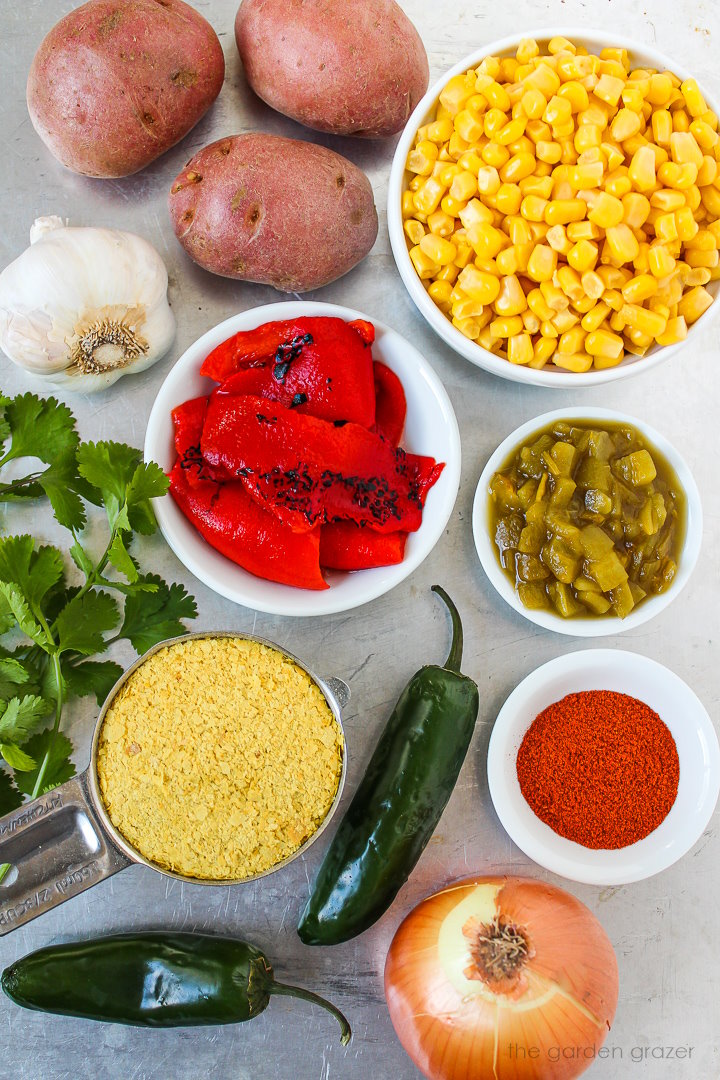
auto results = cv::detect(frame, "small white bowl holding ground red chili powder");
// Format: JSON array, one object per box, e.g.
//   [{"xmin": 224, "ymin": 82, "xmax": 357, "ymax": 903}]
[{"xmin": 488, "ymin": 649, "xmax": 720, "ymax": 885}]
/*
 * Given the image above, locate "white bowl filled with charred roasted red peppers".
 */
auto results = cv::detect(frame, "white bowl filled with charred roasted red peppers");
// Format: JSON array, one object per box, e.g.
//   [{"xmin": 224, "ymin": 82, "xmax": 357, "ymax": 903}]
[{"xmin": 145, "ymin": 301, "xmax": 460, "ymax": 616}]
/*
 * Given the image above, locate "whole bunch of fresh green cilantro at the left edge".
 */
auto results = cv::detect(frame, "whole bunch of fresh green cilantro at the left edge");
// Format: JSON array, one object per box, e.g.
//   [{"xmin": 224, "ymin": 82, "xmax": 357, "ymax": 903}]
[{"xmin": 0, "ymin": 394, "xmax": 198, "ymax": 829}]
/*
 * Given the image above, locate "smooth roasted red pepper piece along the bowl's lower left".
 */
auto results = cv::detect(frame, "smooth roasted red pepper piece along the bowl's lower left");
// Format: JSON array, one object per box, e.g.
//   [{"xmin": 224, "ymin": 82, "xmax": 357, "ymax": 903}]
[{"xmin": 169, "ymin": 397, "xmax": 327, "ymax": 589}]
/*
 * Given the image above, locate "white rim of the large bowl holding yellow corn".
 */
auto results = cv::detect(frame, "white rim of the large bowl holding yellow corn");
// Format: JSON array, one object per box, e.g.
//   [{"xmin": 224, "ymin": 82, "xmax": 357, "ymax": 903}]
[{"xmin": 388, "ymin": 26, "xmax": 720, "ymax": 390}]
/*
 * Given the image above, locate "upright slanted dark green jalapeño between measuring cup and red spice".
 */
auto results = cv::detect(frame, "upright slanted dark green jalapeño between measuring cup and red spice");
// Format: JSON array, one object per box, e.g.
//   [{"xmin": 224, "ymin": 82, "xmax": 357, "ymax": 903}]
[{"xmin": 298, "ymin": 585, "xmax": 479, "ymax": 945}]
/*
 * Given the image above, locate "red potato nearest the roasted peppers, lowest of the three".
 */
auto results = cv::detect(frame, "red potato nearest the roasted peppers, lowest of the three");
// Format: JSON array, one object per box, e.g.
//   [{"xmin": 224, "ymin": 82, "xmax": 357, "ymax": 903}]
[{"xmin": 168, "ymin": 134, "xmax": 378, "ymax": 293}]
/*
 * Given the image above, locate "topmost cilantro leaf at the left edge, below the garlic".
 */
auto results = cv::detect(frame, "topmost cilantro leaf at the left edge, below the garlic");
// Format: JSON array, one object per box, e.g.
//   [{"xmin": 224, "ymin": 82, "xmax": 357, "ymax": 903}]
[{"xmin": 3, "ymin": 393, "xmax": 79, "ymax": 464}]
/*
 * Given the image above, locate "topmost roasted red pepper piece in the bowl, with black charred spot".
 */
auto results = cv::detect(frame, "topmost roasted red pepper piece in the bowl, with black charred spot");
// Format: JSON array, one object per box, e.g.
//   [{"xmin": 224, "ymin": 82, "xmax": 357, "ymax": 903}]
[{"xmin": 201, "ymin": 316, "xmax": 375, "ymax": 428}]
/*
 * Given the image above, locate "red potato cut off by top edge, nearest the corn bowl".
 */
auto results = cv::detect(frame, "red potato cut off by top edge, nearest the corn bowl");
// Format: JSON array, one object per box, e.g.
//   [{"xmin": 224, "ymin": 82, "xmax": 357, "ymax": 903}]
[{"xmin": 235, "ymin": 0, "xmax": 429, "ymax": 138}]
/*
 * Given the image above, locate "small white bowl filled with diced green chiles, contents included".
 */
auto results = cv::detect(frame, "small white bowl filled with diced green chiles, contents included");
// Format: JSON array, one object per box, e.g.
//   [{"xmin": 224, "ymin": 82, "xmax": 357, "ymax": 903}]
[{"xmin": 473, "ymin": 408, "xmax": 703, "ymax": 637}]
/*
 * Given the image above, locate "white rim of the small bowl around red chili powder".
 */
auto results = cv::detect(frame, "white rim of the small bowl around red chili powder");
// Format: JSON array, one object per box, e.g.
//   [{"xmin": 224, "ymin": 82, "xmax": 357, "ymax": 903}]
[{"xmin": 487, "ymin": 649, "xmax": 720, "ymax": 886}]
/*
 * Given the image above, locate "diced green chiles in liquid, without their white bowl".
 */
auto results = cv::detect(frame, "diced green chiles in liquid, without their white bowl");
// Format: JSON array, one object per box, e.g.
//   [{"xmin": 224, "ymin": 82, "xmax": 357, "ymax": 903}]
[{"xmin": 488, "ymin": 420, "xmax": 685, "ymax": 618}]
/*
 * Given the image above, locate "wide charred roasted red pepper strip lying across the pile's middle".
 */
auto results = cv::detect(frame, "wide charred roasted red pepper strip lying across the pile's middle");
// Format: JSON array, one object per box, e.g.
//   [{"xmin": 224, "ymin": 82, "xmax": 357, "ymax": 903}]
[{"xmin": 201, "ymin": 395, "xmax": 443, "ymax": 532}]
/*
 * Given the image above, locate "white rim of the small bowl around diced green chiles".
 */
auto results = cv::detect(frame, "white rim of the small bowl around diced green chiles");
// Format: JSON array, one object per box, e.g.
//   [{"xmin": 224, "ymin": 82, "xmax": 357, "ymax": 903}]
[{"xmin": 473, "ymin": 406, "xmax": 703, "ymax": 637}]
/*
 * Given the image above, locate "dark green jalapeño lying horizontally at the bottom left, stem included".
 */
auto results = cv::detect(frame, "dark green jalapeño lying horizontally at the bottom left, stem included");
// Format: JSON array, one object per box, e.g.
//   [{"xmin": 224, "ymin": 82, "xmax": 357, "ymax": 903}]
[{"xmin": 2, "ymin": 932, "xmax": 351, "ymax": 1045}]
